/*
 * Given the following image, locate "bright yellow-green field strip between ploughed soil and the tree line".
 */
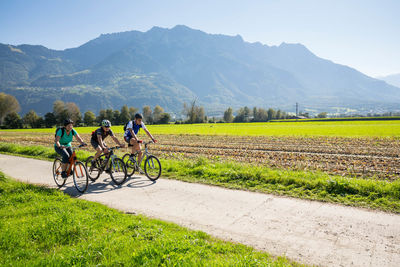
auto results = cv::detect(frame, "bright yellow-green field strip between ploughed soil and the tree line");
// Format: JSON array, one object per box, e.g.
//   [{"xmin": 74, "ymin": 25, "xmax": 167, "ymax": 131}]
[{"xmin": 2, "ymin": 120, "xmax": 400, "ymax": 137}]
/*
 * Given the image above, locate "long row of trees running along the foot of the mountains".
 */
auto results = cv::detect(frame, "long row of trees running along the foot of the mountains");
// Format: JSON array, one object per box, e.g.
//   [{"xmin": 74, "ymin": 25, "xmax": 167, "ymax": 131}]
[{"xmin": 0, "ymin": 93, "xmax": 327, "ymax": 129}]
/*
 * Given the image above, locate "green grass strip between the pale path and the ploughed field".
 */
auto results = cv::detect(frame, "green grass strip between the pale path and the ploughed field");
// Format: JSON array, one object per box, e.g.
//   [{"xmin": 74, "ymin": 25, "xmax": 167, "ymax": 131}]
[{"xmin": 0, "ymin": 143, "xmax": 400, "ymax": 213}]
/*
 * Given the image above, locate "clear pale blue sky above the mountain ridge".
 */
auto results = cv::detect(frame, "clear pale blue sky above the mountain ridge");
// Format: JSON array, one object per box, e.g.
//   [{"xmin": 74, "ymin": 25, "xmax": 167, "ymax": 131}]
[{"xmin": 0, "ymin": 0, "xmax": 400, "ymax": 76}]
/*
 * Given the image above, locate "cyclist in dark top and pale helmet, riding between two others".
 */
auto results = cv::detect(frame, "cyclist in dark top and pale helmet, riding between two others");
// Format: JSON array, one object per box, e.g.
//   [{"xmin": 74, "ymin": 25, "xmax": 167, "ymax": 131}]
[{"xmin": 90, "ymin": 120, "xmax": 125, "ymax": 166}]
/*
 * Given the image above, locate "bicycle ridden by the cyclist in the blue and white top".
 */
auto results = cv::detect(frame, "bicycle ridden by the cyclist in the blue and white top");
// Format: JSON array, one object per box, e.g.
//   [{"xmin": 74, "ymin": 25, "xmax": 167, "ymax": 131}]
[{"xmin": 122, "ymin": 141, "xmax": 162, "ymax": 181}]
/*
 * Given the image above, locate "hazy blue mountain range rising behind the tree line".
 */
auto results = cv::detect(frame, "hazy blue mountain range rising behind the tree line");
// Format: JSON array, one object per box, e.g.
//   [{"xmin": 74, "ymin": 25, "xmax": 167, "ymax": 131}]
[{"xmin": 0, "ymin": 25, "xmax": 400, "ymax": 115}]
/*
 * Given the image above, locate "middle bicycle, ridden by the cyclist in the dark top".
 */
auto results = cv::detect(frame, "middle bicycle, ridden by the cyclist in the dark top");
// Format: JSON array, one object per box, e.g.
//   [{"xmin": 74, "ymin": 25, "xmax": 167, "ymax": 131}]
[{"xmin": 86, "ymin": 146, "xmax": 127, "ymax": 185}]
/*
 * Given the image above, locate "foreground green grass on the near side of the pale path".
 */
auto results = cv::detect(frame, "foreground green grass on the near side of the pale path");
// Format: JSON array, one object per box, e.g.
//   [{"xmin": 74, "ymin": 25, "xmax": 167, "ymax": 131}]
[{"xmin": 0, "ymin": 173, "xmax": 298, "ymax": 266}]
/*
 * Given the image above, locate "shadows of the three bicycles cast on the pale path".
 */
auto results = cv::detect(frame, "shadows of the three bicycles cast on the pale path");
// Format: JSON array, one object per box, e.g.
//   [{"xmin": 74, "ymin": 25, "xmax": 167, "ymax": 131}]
[{"xmin": 63, "ymin": 175, "xmax": 156, "ymax": 197}]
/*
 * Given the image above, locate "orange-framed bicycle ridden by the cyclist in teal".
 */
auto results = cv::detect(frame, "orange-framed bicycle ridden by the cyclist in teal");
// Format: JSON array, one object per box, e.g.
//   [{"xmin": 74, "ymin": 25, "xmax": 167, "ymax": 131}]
[{"xmin": 53, "ymin": 145, "xmax": 89, "ymax": 193}]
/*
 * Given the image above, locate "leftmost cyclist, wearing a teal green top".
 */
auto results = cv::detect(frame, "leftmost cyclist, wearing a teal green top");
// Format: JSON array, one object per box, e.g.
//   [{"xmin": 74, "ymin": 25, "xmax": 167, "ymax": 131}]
[{"xmin": 54, "ymin": 119, "xmax": 86, "ymax": 178}]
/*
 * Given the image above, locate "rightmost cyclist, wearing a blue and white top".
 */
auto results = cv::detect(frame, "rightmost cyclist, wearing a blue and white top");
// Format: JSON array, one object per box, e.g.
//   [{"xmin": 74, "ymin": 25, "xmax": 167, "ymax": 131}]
[{"xmin": 124, "ymin": 113, "xmax": 157, "ymax": 173}]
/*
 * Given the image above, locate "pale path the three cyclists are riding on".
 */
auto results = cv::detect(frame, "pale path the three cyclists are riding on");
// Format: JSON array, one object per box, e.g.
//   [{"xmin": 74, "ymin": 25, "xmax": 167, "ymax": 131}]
[{"xmin": 0, "ymin": 155, "xmax": 400, "ymax": 266}]
